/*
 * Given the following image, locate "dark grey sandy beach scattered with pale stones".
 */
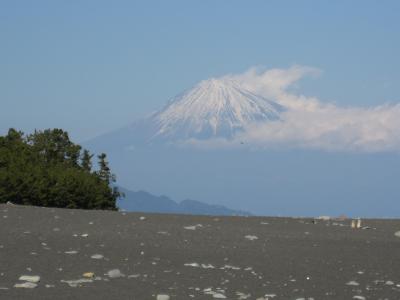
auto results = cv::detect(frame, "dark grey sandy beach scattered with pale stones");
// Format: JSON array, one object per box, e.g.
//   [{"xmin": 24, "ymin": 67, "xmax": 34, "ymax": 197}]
[{"xmin": 0, "ymin": 205, "xmax": 400, "ymax": 300}]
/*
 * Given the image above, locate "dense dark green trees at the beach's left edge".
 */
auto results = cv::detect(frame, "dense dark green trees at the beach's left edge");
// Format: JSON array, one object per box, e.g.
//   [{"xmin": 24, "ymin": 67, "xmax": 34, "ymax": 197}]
[{"xmin": 0, "ymin": 129, "xmax": 121, "ymax": 210}]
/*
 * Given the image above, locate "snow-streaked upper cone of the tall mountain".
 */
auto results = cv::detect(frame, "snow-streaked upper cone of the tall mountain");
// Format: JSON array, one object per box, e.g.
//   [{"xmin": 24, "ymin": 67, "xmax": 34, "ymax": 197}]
[{"xmin": 150, "ymin": 78, "xmax": 284, "ymax": 140}]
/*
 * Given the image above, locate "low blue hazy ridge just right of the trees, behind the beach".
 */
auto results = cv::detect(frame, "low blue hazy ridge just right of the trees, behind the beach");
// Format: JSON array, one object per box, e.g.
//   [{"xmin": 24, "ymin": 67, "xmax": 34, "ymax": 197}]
[{"xmin": 117, "ymin": 188, "xmax": 251, "ymax": 216}]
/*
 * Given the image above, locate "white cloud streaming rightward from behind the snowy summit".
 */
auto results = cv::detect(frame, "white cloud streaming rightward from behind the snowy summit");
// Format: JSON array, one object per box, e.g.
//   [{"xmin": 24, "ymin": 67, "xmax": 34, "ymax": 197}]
[{"xmin": 214, "ymin": 65, "xmax": 400, "ymax": 152}]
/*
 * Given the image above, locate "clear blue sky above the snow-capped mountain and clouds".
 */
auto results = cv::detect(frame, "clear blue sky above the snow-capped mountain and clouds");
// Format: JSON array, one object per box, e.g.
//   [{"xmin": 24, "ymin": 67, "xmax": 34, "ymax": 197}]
[{"xmin": 0, "ymin": 0, "xmax": 400, "ymax": 141}]
